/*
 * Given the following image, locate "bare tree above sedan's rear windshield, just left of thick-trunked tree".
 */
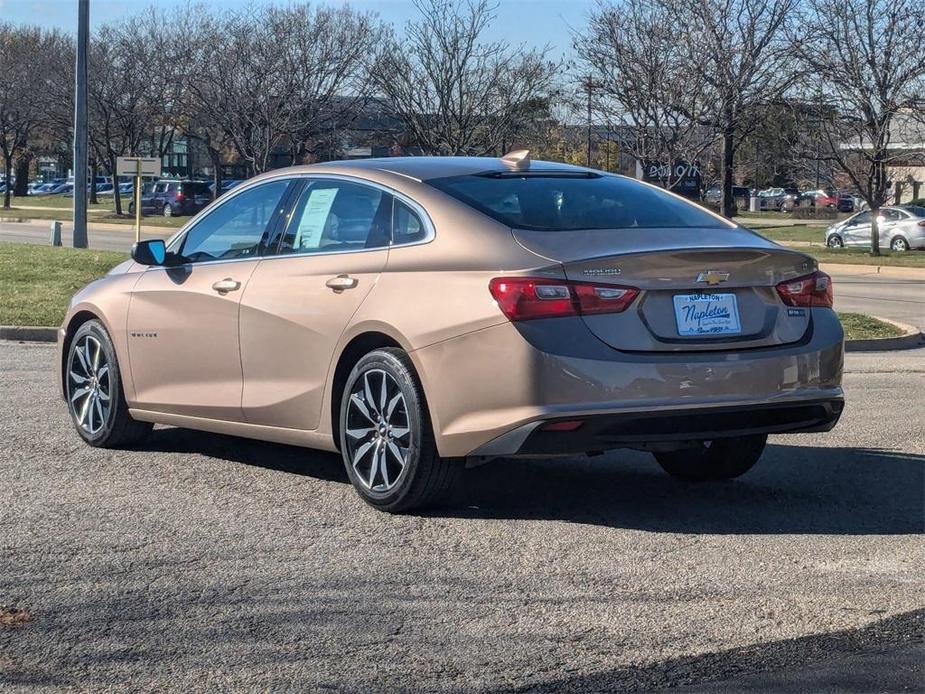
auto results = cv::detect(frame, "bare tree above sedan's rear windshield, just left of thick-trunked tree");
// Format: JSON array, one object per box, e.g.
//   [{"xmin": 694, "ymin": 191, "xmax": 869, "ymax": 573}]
[{"xmin": 574, "ymin": 0, "xmax": 716, "ymax": 188}]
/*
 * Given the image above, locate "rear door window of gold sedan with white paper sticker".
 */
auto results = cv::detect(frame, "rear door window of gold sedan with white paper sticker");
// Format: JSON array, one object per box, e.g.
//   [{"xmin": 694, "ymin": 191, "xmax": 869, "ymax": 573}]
[{"xmin": 280, "ymin": 179, "xmax": 392, "ymax": 253}]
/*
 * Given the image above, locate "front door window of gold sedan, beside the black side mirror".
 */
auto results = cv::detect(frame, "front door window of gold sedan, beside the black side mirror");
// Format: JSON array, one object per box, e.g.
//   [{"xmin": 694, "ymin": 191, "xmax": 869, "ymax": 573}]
[{"xmin": 179, "ymin": 180, "xmax": 290, "ymax": 263}]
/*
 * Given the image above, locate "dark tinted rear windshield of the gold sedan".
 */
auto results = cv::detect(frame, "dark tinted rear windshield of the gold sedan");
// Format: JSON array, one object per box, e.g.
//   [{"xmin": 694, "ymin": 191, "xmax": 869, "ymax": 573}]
[{"xmin": 427, "ymin": 172, "xmax": 721, "ymax": 231}]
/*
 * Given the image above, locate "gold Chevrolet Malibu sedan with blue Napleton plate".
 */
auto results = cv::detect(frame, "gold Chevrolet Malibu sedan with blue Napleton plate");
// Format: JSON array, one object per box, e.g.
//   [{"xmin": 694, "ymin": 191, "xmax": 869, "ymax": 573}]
[{"xmin": 59, "ymin": 151, "xmax": 843, "ymax": 512}]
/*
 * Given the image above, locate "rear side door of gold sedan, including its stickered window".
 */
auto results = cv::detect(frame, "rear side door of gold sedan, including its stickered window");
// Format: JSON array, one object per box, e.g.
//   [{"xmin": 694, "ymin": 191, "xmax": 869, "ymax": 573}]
[{"xmin": 241, "ymin": 177, "xmax": 392, "ymax": 430}]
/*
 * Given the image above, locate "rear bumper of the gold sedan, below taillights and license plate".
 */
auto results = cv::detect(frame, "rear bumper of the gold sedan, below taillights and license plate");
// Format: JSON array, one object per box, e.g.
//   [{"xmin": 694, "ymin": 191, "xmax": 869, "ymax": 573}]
[{"xmin": 411, "ymin": 309, "xmax": 844, "ymax": 456}]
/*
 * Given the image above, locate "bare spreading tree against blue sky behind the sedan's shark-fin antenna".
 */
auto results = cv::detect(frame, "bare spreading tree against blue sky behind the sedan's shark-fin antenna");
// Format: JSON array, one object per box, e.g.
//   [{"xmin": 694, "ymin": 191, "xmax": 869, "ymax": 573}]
[{"xmin": 372, "ymin": 0, "xmax": 555, "ymax": 155}]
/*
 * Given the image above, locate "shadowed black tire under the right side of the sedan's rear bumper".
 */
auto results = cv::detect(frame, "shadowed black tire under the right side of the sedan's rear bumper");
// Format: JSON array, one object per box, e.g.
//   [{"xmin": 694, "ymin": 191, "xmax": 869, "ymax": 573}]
[{"xmin": 655, "ymin": 434, "xmax": 768, "ymax": 481}]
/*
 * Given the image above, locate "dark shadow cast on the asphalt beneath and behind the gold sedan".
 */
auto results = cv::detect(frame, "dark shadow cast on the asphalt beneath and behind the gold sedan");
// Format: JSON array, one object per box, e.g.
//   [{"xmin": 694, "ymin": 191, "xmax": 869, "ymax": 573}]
[{"xmin": 134, "ymin": 429, "xmax": 925, "ymax": 535}]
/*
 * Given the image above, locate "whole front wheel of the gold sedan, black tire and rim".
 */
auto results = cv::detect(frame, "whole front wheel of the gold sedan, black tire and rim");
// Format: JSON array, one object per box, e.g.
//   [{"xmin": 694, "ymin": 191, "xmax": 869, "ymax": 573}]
[{"xmin": 63, "ymin": 320, "xmax": 154, "ymax": 448}]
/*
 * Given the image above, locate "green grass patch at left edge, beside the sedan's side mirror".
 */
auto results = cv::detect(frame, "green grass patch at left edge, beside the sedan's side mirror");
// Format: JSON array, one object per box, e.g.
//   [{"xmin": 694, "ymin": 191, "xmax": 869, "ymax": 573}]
[{"xmin": 0, "ymin": 241, "xmax": 128, "ymax": 325}]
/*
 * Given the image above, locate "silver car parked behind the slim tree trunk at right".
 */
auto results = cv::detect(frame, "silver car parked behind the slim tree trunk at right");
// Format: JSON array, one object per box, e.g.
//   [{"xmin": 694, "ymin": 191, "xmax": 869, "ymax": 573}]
[{"xmin": 825, "ymin": 205, "xmax": 925, "ymax": 253}]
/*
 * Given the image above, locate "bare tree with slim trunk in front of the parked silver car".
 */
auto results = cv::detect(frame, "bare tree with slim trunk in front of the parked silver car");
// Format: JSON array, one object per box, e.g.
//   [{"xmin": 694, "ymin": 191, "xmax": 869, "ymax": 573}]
[{"xmin": 794, "ymin": 0, "xmax": 925, "ymax": 255}]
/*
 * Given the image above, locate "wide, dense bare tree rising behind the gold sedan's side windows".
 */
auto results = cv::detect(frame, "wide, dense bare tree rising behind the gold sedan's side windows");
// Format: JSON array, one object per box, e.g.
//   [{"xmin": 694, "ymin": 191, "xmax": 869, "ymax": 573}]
[{"xmin": 186, "ymin": 4, "xmax": 380, "ymax": 179}]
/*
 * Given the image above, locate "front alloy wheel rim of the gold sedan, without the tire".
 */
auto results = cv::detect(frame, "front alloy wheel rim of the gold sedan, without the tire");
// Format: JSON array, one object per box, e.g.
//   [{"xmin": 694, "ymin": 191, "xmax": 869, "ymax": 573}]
[{"xmin": 67, "ymin": 335, "xmax": 112, "ymax": 436}]
